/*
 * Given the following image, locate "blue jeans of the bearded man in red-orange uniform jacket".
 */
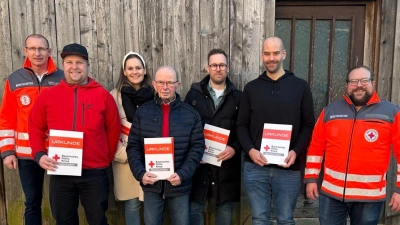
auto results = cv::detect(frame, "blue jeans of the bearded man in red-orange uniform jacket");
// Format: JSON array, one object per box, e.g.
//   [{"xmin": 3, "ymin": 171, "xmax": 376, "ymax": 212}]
[{"xmin": 318, "ymin": 194, "xmax": 384, "ymax": 225}]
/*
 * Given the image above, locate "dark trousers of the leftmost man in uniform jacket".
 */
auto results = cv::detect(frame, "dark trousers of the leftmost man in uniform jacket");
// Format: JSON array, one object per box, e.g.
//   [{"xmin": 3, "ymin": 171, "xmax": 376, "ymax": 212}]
[{"xmin": 18, "ymin": 159, "xmax": 44, "ymax": 225}]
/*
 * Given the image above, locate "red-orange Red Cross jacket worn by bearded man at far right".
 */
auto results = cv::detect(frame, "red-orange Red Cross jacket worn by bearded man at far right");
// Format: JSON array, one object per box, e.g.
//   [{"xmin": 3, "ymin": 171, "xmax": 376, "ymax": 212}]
[{"xmin": 304, "ymin": 92, "xmax": 400, "ymax": 202}]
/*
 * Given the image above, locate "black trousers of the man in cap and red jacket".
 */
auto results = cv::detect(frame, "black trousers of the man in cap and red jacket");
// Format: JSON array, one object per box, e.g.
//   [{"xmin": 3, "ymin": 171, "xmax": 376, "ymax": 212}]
[{"xmin": 50, "ymin": 169, "xmax": 110, "ymax": 225}]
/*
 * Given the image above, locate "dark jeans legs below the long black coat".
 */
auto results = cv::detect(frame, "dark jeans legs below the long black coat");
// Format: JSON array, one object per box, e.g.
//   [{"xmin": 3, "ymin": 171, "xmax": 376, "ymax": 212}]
[{"xmin": 189, "ymin": 201, "xmax": 232, "ymax": 225}]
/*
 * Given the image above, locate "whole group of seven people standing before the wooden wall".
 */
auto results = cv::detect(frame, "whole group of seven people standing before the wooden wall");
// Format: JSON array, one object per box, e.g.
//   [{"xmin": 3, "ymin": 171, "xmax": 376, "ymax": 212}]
[{"xmin": 0, "ymin": 34, "xmax": 400, "ymax": 225}]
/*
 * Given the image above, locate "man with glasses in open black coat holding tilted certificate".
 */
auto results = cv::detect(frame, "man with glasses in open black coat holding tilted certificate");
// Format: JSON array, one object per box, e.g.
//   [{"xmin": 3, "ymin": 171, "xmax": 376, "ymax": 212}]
[{"xmin": 185, "ymin": 49, "xmax": 242, "ymax": 225}]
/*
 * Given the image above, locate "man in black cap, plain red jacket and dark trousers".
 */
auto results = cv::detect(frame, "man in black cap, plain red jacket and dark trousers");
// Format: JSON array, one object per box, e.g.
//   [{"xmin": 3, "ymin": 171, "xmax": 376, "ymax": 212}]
[{"xmin": 28, "ymin": 44, "xmax": 121, "ymax": 225}]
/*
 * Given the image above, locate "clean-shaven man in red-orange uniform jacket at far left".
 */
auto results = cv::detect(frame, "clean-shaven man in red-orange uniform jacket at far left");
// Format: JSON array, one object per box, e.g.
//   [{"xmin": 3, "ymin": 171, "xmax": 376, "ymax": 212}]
[{"xmin": 0, "ymin": 34, "xmax": 64, "ymax": 225}]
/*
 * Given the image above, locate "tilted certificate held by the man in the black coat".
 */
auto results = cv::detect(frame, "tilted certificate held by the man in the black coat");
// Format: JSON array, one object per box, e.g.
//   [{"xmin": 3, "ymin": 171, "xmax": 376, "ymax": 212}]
[{"xmin": 202, "ymin": 124, "xmax": 230, "ymax": 166}]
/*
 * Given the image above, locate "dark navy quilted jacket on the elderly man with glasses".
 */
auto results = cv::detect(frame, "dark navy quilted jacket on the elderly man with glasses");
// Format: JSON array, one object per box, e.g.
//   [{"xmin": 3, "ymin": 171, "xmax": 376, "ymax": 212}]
[{"xmin": 126, "ymin": 94, "xmax": 205, "ymax": 197}]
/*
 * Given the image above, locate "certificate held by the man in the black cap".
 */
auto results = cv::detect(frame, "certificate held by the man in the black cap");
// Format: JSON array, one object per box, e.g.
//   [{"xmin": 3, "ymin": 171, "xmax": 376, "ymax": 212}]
[{"xmin": 47, "ymin": 130, "xmax": 83, "ymax": 176}]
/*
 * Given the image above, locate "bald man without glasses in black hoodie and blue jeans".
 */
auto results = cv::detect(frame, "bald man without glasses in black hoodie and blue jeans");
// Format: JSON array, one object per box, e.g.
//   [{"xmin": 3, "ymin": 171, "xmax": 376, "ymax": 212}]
[{"xmin": 237, "ymin": 37, "xmax": 315, "ymax": 225}]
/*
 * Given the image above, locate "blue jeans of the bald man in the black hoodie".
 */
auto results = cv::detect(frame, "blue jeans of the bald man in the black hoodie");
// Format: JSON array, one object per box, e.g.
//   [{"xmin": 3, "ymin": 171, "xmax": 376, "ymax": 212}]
[{"xmin": 244, "ymin": 162, "xmax": 300, "ymax": 225}]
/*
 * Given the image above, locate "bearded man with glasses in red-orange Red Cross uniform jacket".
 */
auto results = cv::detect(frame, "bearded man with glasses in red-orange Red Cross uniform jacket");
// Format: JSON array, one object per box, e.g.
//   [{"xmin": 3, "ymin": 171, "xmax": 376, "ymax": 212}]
[{"xmin": 304, "ymin": 66, "xmax": 400, "ymax": 225}]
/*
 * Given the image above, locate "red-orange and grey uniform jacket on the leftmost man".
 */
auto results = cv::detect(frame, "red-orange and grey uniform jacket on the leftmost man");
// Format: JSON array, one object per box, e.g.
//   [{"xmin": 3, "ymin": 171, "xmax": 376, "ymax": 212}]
[{"xmin": 0, "ymin": 57, "xmax": 64, "ymax": 159}]
